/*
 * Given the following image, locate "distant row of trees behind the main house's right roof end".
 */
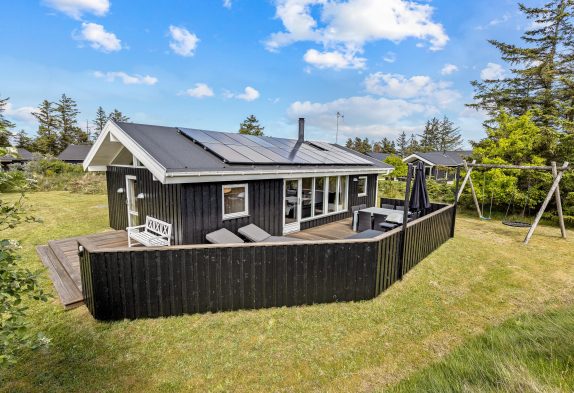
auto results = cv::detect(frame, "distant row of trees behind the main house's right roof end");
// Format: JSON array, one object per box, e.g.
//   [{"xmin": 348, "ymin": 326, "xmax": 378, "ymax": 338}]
[{"xmin": 345, "ymin": 116, "xmax": 463, "ymax": 157}]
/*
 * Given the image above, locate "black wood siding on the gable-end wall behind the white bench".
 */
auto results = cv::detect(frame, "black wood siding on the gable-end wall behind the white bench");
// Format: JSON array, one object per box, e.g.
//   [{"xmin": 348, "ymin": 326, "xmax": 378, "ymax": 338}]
[{"xmin": 106, "ymin": 166, "xmax": 185, "ymax": 244}]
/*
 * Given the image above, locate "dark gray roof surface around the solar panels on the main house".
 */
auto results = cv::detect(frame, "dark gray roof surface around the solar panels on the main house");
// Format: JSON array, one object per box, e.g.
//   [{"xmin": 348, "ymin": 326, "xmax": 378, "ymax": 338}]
[{"xmin": 116, "ymin": 122, "xmax": 392, "ymax": 172}]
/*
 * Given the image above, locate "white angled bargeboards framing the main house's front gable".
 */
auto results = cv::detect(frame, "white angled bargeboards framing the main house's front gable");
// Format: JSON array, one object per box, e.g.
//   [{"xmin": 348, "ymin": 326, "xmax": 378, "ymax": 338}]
[{"xmin": 83, "ymin": 119, "xmax": 166, "ymax": 183}]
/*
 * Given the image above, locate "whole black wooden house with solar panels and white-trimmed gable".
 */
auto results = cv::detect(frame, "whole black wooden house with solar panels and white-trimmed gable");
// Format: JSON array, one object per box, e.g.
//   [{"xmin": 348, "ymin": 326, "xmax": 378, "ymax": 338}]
[{"xmin": 84, "ymin": 119, "xmax": 393, "ymax": 244}]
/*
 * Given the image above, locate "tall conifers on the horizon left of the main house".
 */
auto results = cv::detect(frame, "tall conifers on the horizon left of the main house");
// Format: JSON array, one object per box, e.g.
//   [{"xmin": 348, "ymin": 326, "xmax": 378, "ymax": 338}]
[{"xmin": 0, "ymin": 94, "xmax": 129, "ymax": 156}]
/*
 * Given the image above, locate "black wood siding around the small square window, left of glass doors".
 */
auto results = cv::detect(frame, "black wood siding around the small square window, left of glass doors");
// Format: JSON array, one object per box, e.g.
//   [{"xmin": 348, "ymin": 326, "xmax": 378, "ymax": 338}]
[{"xmin": 182, "ymin": 179, "xmax": 283, "ymax": 244}]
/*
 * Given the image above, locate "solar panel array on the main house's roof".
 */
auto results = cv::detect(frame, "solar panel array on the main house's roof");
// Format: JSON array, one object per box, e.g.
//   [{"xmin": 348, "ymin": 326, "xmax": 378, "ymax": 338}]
[{"xmin": 179, "ymin": 128, "xmax": 372, "ymax": 165}]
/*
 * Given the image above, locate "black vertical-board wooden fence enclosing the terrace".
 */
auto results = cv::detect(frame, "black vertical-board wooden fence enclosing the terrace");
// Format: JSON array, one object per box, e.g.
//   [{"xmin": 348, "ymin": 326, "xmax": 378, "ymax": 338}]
[{"xmin": 79, "ymin": 205, "xmax": 456, "ymax": 320}]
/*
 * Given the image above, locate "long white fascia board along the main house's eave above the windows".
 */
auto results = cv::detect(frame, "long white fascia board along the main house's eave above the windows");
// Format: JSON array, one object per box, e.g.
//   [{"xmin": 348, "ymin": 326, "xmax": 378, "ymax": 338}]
[{"xmin": 164, "ymin": 168, "xmax": 393, "ymax": 184}]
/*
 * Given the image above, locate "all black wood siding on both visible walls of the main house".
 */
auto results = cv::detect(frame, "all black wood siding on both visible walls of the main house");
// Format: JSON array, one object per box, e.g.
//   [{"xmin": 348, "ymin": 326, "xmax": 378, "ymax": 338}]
[{"xmin": 106, "ymin": 166, "xmax": 377, "ymax": 244}]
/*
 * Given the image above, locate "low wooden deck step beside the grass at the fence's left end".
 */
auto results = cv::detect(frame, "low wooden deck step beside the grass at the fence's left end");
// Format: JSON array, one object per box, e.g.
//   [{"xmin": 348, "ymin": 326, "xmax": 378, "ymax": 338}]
[{"xmin": 36, "ymin": 246, "xmax": 84, "ymax": 309}]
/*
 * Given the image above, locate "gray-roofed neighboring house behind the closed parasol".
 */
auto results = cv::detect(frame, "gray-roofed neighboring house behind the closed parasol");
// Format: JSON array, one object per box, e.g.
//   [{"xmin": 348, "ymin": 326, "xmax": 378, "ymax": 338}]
[{"xmin": 403, "ymin": 150, "xmax": 472, "ymax": 181}]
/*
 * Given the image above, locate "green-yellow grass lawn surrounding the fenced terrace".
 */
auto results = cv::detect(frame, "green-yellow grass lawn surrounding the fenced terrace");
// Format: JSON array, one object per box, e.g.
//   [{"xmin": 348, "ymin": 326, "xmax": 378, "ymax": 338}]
[{"xmin": 0, "ymin": 192, "xmax": 574, "ymax": 392}]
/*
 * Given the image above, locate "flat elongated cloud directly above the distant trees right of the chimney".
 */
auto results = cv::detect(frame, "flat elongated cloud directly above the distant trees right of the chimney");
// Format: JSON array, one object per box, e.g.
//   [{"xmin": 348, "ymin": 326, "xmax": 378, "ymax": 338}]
[{"xmin": 365, "ymin": 72, "xmax": 460, "ymax": 108}]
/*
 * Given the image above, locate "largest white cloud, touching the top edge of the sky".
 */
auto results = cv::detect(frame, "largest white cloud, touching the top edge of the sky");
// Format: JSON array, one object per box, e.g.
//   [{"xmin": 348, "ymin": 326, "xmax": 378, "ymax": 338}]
[{"xmin": 265, "ymin": 0, "xmax": 448, "ymax": 68}]
